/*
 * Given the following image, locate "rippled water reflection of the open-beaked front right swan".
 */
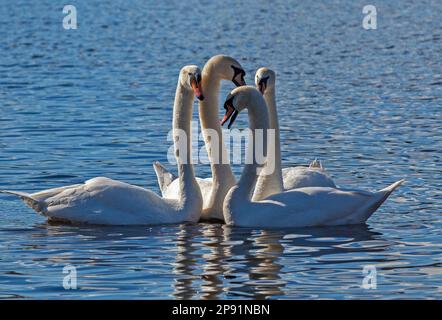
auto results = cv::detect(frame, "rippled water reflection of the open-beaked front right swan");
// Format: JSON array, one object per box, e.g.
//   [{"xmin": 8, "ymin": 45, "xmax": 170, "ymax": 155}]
[{"xmin": 226, "ymin": 226, "xmax": 375, "ymax": 299}]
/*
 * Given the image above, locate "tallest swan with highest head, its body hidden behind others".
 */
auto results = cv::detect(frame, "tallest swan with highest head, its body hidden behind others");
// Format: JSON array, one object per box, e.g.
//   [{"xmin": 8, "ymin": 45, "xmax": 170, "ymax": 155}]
[{"xmin": 153, "ymin": 55, "xmax": 245, "ymax": 221}]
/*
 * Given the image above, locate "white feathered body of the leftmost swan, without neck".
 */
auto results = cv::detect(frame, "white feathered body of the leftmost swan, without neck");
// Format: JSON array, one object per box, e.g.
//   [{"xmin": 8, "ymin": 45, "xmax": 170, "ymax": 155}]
[{"xmin": 0, "ymin": 177, "xmax": 198, "ymax": 225}]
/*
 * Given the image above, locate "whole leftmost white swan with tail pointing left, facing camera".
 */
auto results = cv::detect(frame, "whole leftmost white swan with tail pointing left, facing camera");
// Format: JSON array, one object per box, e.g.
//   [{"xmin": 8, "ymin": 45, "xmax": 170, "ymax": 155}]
[{"xmin": 1, "ymin": 66, "xmax": 202, "ymax": 225}]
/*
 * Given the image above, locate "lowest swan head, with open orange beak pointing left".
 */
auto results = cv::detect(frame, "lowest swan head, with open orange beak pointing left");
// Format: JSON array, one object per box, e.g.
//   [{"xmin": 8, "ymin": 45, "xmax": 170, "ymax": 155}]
[{"xmin": 221, "ymin": 86, "xmax": 265, "ymax": 129}]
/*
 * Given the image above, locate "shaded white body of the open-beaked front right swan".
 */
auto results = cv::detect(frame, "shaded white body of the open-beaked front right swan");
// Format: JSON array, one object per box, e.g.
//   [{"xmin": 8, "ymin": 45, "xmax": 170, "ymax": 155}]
[{"xmin": 225, "ymin": 180, "xmax": 403, "ymax": 228}]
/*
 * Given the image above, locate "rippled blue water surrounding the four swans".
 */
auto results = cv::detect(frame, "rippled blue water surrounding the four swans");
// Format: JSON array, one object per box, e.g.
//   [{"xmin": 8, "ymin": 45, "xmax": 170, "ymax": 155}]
[{"xmin": 0, "ymin": 0, "xmax": 442, "ymax": 299}]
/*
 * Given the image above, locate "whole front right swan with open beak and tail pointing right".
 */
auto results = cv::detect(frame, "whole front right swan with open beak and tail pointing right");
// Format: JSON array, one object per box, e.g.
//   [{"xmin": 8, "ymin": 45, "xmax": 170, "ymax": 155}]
[{"xmin": 223, "ymin": 86, "xmax": 403, "ymax": 227}]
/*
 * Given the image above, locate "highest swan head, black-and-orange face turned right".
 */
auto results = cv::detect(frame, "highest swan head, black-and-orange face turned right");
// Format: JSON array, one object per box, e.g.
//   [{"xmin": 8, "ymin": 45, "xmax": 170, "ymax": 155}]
[{"xmin": 206, "ymin": 55, "xmax": 246, "ymax": 87}]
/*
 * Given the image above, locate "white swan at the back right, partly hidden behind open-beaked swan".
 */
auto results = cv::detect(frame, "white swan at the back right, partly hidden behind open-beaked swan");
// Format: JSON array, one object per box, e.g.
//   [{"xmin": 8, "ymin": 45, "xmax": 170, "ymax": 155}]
[{"xmin": 252, "ymin": 67, "xmax": 336, "ymax": 201}]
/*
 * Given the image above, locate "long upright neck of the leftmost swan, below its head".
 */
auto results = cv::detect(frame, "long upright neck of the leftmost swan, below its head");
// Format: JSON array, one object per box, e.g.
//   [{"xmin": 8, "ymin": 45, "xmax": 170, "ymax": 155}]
[{"xmin": 172, "ymin": 80, "xmax": 200, "ymax": 206}]
